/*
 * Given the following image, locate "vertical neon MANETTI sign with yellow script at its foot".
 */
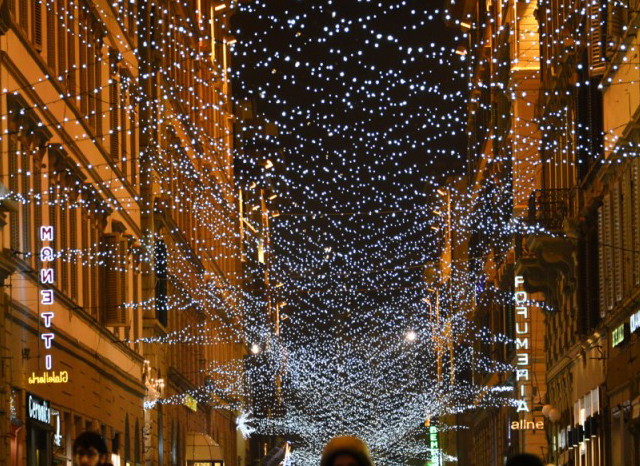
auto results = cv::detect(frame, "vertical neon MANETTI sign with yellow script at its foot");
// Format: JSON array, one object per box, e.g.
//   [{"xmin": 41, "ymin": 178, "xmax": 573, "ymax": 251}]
[{"xmin": 29, "ymin": 226, "xmax": 69, "ymax": 384}]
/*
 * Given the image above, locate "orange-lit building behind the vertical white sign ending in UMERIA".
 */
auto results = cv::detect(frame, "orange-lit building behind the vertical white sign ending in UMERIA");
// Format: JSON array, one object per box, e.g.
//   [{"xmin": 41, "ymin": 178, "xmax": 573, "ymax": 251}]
[{"xmin": 447, "ymin": 0, "xmax": 547, "ymax": 466}]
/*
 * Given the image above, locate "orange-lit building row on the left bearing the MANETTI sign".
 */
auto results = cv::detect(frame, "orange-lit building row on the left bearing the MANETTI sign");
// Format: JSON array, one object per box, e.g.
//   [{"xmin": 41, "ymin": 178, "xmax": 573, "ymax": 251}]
[{"xmin": 0, "ymin": 0, "xmax": 245, "ymax": 466}]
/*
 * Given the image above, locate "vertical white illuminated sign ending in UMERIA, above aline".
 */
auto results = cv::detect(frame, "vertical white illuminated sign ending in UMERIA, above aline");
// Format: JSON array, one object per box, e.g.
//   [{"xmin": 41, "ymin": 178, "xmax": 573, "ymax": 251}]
[{"xmin": 514, "ymin": 276, "xmax": 531, "ymax": 413}]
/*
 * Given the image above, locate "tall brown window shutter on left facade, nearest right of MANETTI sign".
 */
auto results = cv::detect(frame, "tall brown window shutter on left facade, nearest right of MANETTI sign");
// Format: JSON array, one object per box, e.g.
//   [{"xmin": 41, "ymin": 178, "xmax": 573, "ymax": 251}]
[{"xmin": 100, "ymin": 233, "xmax": 126, "ymax": 327}]
